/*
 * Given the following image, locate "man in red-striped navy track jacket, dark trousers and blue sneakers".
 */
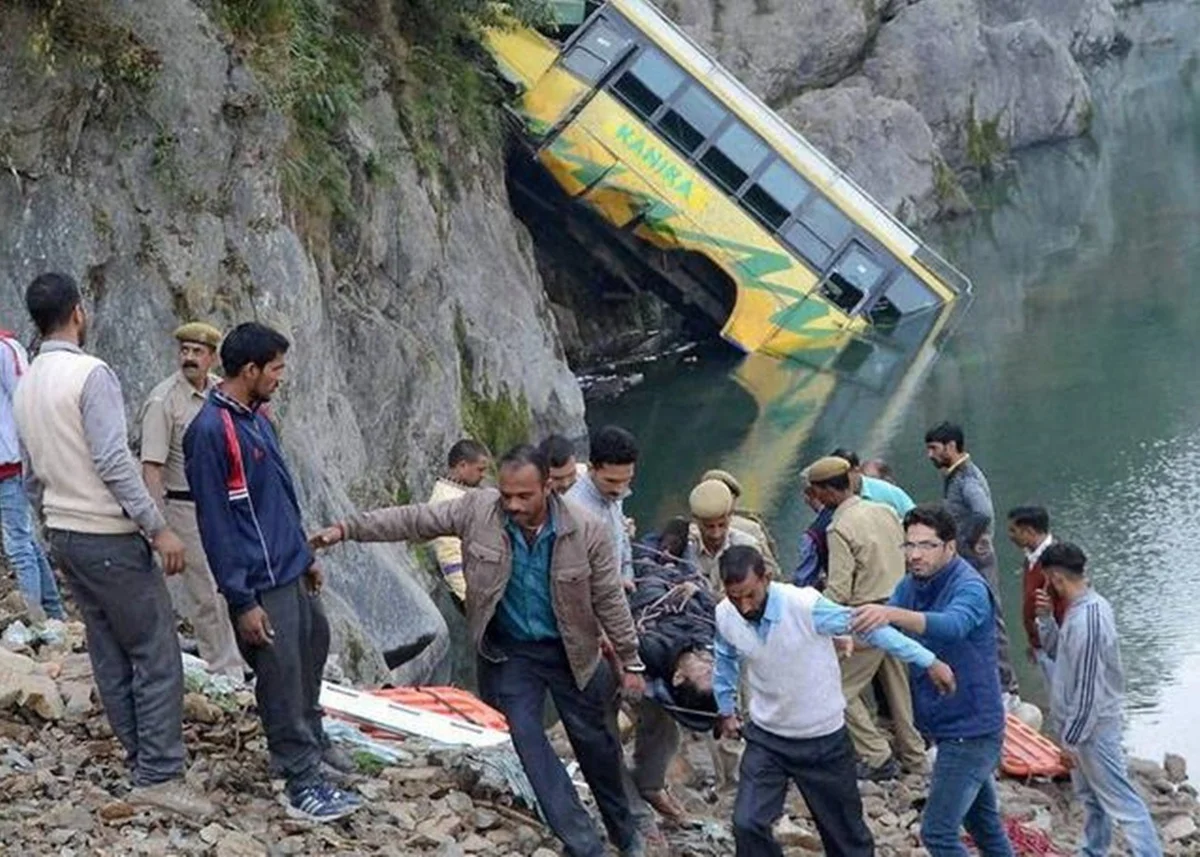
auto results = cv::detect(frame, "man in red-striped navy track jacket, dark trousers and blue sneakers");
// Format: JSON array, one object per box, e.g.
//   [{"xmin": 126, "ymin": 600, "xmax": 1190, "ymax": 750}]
[{"xmin": 184, "ymin": 323, "xmax": 359, "ymax": 821}]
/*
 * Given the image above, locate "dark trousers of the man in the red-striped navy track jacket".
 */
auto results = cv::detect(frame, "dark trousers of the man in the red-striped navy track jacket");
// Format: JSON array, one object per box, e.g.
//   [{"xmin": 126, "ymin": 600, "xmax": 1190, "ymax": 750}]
[{"xmin": 238, "ymin": 579, "xmax": 329, "ymax": 795}]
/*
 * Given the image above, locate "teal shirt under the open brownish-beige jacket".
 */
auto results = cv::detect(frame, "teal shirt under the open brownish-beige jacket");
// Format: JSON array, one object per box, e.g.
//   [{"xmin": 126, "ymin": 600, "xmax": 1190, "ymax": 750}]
[{"xmin": 496, "ymin": 517, "xmax": 559, "ymax": 641}]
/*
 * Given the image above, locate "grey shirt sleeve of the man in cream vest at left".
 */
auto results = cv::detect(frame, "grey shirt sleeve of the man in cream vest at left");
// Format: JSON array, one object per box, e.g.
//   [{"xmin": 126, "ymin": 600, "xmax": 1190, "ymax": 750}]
[{"xmin": 79, "ymin": 366, "xmax": 167, "ymax": 537}]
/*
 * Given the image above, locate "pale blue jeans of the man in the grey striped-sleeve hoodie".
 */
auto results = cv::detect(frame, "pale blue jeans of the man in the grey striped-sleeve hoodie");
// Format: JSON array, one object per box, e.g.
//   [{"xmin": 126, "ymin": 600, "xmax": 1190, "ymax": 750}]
[{"xmin": 1070, "ymin": 725, "xmax": 1163, "ymax": 857}]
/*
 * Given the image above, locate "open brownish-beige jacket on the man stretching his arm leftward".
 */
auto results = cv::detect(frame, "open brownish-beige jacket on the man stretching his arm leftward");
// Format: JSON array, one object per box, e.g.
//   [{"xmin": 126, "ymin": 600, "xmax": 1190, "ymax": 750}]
[{"xmin": 342, "ymin": 489, "xmax": 642, "ymax": 688}]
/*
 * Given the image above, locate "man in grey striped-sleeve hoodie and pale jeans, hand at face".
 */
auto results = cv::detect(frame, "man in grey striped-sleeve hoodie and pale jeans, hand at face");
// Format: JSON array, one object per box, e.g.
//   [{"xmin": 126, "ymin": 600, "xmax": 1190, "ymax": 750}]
[{"xmin": 1037, "ymin": 541, "xmax": 1163, "ymax": 857}]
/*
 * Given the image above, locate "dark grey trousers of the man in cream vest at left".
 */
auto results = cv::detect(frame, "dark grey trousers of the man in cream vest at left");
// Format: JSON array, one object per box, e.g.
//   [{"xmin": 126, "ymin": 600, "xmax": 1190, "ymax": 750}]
[{"xmin": 49, "ymin": 529, "xmax": 184, "ymax": 786}]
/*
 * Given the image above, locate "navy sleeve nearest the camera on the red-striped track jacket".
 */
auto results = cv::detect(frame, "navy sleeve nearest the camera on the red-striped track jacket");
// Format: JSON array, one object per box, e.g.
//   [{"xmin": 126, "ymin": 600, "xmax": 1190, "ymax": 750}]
[{"xmin": 184, "ymin": 422, "xmax": 258, "ymax": 609}]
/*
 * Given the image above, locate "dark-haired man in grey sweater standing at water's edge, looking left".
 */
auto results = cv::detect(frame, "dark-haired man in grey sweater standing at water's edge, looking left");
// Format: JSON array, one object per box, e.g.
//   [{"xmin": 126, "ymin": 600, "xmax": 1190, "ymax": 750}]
[{"xmin": 925, "ymin": 422, "xmax": 1019, "ymax": 696}]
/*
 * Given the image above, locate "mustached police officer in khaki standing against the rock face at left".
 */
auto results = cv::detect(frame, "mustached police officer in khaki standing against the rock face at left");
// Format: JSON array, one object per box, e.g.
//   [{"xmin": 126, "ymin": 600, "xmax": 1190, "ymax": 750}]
[{"xmin": 142, "ymin": 322, "xmax": 246, "ymax": 678}]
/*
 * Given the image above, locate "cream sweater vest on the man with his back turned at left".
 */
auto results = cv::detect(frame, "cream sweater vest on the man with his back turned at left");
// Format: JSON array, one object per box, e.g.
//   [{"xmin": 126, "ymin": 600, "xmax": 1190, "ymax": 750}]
[{"xmin": 13, "ymin": 350, "xmax": 138, "ymax": 534}]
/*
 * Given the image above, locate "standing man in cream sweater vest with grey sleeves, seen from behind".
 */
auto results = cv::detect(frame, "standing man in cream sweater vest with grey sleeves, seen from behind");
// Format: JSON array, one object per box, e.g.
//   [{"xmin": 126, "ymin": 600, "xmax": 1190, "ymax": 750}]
[{"xmin": 14, "ymin": 274, "xmax": 214, "ymax": 817}]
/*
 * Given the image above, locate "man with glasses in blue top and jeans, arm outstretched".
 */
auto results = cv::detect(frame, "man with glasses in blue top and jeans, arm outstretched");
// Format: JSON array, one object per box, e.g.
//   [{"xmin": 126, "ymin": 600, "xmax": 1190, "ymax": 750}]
[{"xmin": 852, "ymin": 504, "xmax": 1013, "ymax": 857}]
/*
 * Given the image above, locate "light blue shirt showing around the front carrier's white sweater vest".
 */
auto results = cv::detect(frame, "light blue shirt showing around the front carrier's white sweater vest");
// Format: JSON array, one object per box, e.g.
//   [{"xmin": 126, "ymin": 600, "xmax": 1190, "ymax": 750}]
[{"xmin": 713, "ymin": 595, "xmax": 936, "ymax": 717}]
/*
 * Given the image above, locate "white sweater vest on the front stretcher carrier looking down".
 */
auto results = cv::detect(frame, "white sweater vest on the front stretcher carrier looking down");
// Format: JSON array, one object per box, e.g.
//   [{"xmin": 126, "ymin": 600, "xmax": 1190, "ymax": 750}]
[{"xmin": 716, "ymin": 583, "xmax": 846, "ymax": 738}]
